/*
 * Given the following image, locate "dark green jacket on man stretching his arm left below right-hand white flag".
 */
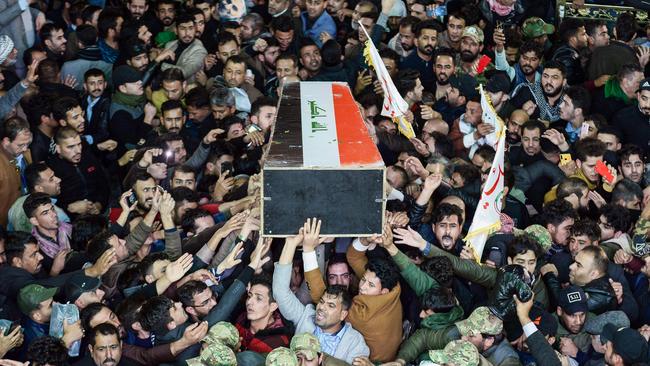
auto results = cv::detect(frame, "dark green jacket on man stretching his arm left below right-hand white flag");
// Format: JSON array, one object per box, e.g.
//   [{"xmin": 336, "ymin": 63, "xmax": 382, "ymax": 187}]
[{"xmin": 428, "ymin": 245, "xmax": 549, "ymax": 309}]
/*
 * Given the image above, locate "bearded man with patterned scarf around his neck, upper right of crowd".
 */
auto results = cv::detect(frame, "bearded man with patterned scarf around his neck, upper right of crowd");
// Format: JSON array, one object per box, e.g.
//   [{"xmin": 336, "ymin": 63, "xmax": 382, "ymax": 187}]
[{"xmin": 510, "ymin": 60, "xmax": 564, "ymax": 123}]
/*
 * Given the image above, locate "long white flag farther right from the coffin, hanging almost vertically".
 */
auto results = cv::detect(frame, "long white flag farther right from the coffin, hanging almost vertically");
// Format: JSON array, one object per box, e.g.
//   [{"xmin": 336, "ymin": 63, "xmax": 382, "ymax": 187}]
[{"xmin": 464, "ymin": 85, "xmax": 506, "ymax": 260}]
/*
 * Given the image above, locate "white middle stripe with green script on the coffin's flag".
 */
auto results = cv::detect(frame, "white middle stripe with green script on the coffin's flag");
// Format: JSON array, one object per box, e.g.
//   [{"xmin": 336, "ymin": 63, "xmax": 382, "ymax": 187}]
[{"xmin": 300, "ymin": 82, "xmax": 340, "ymax": 167}]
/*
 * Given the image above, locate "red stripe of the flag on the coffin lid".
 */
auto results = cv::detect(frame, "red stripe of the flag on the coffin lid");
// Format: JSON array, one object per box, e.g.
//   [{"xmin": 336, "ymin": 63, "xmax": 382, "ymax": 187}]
[{"xmin": 332, "ymin": 83, "xmax": 382, "ymax": 166}]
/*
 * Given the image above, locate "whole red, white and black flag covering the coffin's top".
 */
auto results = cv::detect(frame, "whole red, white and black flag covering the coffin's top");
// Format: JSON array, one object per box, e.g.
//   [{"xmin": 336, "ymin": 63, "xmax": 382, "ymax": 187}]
[{"xmin": 265, "ymin": 81, "xmax": 384, "ymax": 168}]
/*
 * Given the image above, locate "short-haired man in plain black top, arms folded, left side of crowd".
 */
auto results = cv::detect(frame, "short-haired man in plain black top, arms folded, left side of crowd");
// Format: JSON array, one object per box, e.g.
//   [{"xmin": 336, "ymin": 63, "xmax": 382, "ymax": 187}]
[{"xmin": 48, "ymin": 127, "xmax": 110, "ymax": 215}]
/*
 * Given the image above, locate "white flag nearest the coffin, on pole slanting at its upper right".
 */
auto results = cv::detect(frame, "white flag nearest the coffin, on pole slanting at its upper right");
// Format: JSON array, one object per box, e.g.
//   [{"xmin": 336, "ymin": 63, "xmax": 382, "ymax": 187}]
[{"xmin": 359, "ymin": 24, "xmax": 415, "ymax": 139}]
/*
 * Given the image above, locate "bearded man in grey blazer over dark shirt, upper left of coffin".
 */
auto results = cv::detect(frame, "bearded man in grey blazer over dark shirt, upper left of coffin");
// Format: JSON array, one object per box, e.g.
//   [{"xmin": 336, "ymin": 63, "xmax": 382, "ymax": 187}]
[{"xmin": 160, "ymin": 14, "xmax": 208, "ymax": 83}]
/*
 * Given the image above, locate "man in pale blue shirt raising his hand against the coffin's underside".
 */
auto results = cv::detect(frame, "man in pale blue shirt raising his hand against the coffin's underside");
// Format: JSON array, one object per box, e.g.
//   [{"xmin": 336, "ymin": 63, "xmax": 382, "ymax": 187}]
[{"xmin": 273, "ymin": 229, "xmax": 370, "ymax": 363}]
